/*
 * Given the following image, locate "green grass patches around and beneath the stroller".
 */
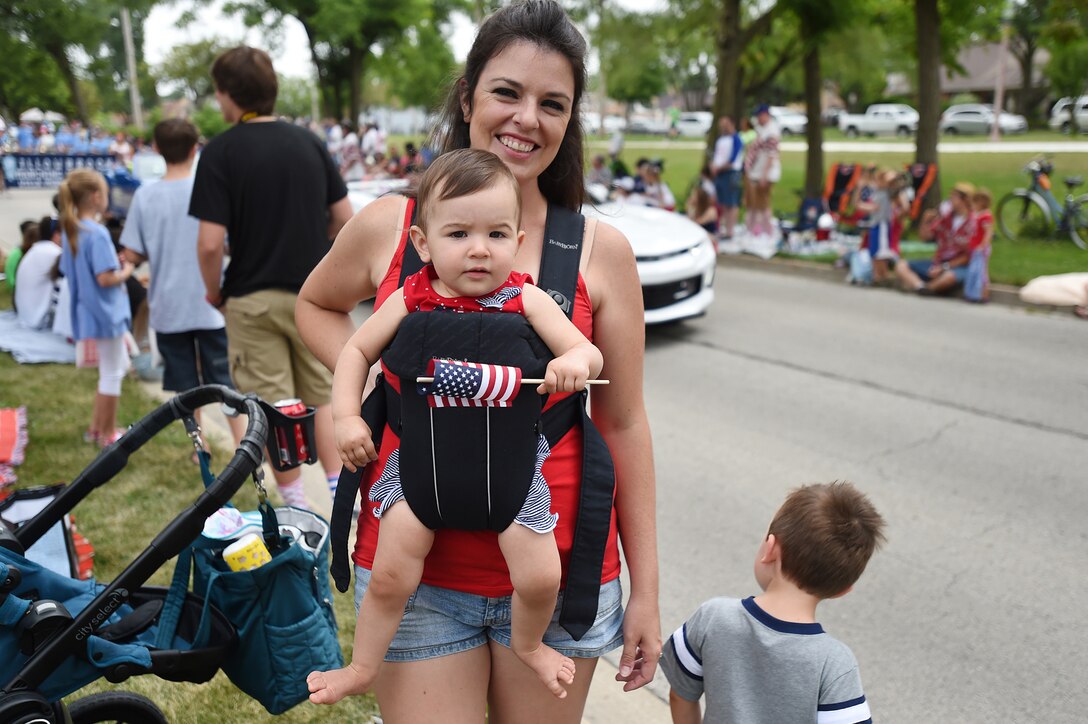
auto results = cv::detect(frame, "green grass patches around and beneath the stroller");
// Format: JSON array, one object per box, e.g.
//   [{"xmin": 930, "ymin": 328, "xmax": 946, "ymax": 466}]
[{"xmin": 0, "ymin": 287, "xmax": 376, "ymax": 724}]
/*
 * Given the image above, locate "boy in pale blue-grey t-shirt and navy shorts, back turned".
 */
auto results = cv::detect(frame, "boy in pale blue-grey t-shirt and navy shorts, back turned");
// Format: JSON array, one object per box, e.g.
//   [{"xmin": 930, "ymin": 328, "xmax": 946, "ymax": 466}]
[{"xmin": 121, "ymin": 119, "xmax": 246, "ymax": 446}]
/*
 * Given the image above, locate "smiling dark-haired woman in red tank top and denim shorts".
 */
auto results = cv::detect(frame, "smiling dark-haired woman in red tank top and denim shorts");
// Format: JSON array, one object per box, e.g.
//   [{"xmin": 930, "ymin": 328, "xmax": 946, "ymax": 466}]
[{"xmin": 296, "ymin": 0, "xmax": 662, "ymax": 724}]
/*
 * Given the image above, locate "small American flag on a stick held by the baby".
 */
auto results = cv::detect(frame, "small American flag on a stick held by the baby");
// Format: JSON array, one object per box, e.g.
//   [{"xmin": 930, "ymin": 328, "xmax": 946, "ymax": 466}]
[{"xmin": 419, "ymin": 359, "xmax": 521, "ymax": 407}]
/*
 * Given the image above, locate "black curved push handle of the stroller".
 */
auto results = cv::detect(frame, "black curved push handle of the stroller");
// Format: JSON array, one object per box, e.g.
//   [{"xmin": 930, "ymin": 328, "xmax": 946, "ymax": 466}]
[{"xmin": 0, "ymin": 384, "xmax": 268, "ymax": 691}]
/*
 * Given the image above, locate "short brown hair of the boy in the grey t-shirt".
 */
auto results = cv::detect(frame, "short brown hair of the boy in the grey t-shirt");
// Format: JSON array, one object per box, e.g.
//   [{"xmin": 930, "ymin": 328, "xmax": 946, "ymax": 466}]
[{"xmin": 767, "ymin": 481, "xmax": 885, "ymax": 599}]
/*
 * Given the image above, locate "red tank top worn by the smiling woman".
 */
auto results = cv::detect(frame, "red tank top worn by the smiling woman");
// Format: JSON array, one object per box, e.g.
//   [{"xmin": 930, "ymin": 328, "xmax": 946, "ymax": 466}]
[{"xmin": 351, "ymin": 201, "xmax": 619, "ymax": 598}]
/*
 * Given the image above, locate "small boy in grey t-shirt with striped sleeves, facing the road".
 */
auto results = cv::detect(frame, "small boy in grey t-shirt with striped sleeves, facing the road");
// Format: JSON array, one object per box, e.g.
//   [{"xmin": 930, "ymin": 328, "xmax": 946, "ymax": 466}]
[{"xmin": 660, "ymin": 482, "xmax": 885, "ymax": 724}]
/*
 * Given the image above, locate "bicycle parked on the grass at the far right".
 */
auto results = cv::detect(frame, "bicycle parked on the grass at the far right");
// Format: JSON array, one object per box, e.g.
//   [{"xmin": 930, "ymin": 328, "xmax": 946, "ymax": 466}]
[{"xmin": 997, "ymin": 158, "xmax": 1088, "ymax": 249}]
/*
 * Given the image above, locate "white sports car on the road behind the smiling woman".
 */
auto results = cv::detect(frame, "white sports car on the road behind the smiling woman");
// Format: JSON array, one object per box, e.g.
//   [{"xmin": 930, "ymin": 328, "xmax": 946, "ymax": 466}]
[{"xmin": 347, "ymin": 180, "xmax": 717, "ymax": 324}]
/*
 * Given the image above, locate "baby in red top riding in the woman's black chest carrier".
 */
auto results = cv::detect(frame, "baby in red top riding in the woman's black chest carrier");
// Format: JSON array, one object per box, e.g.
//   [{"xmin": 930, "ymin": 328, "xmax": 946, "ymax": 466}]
[{"xmin": 308, "ymin": 149, "xmax": 604, "ymax": 703}]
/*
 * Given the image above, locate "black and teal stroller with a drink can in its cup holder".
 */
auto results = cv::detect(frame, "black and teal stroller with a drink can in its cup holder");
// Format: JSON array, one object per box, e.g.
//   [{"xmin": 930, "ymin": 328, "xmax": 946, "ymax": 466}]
[{"xmin": 0, "ymin": 385, "xmax": 313, "ymax": 724}]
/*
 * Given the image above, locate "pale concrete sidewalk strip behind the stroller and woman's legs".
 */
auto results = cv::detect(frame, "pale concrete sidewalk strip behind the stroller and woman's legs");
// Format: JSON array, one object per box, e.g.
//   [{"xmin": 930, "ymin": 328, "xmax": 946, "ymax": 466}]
[{"xmin": 140, "ymin": 381, "xmax": 671, "ymax": 724}]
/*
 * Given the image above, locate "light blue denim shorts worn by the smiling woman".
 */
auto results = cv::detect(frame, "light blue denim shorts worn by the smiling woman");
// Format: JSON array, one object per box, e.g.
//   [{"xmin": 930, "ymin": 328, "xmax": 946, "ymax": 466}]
[{"xmin": 355, "ymin": 566, "xmax": 623, "ymax": 662}]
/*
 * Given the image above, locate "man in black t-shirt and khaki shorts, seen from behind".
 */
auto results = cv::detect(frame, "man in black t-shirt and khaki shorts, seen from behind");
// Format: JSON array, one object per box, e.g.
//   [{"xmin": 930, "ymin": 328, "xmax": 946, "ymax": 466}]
[{"xmin": 190, "ymin": 46, "xmax": 351, "ymax": 508}]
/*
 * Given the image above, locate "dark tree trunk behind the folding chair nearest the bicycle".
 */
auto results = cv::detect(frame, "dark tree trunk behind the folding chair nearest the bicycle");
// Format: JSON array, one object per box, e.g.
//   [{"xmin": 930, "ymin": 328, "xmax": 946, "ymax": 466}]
[{"xmin": 914, "ymin": 0, "xmax": 941, "ymax": 209}]
